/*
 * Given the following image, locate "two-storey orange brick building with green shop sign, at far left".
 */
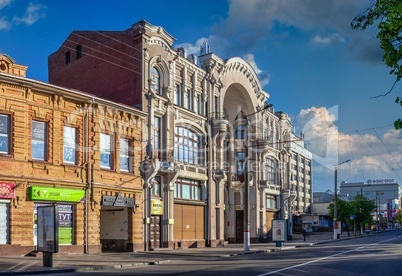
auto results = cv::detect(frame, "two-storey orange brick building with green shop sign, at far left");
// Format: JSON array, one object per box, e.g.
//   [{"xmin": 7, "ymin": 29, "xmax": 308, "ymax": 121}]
[{"xmin": 0, "ymin": 55, "xmax": 146, "ymax": 255}]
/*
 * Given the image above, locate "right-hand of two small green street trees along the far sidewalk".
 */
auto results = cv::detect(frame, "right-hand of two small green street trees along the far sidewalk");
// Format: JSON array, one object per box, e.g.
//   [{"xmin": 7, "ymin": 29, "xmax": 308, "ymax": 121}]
[{"xmin": 351, "ymin": 195, "xmax": 377, "ymax": 233}]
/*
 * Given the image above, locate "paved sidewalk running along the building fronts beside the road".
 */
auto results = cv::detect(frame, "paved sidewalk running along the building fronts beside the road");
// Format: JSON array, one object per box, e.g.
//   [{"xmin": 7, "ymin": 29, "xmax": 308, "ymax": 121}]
[{"xmin": 0, "ymin": 232, "xmax": 359, "ymax": 275}]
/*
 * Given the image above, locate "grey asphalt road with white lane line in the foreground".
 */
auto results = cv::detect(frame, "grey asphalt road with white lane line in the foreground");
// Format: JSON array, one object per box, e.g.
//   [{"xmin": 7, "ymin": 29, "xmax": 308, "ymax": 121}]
[{"xmin": 59, "ymin": 231, "xmax": 402, "ymax": 276}]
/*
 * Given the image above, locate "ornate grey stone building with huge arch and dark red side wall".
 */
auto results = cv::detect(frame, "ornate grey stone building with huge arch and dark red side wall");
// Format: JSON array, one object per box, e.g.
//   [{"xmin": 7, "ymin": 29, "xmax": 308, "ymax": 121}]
[{"xmin": 49, "ymin": 21, "xmax": 302, "ymax": 248}]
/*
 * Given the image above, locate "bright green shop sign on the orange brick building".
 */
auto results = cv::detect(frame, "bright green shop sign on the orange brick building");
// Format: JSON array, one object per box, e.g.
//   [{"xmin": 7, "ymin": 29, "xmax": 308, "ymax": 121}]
[{"xmin": 29, "ymin": 186, "xmax": 85, "ymax": 203}]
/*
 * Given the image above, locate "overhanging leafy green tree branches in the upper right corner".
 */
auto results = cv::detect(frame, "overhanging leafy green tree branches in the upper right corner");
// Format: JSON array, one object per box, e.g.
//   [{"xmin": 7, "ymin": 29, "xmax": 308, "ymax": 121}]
[{"xmin": 351, "ymin": 0, "xmax": 402, "ymax": 129}]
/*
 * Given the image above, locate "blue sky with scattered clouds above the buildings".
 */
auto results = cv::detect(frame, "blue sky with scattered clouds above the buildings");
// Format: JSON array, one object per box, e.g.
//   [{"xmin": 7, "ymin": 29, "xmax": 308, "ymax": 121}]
[{"xmin": 0, "ymin": 0, "xmax": 402, "ymax": 192}]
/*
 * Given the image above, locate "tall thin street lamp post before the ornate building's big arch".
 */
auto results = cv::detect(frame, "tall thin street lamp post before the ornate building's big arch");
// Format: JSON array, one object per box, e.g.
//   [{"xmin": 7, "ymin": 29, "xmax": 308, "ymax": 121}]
[{"xmin": 243, "ymin": 104, "xmax": 272, "ymax": 251}]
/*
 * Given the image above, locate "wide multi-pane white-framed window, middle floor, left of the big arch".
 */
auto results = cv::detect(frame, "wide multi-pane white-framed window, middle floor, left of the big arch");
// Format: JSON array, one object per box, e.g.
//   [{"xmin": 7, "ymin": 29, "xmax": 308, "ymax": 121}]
[{"xmin": 174, "ymin": 127, "xmax": 204, "ymax": 165}]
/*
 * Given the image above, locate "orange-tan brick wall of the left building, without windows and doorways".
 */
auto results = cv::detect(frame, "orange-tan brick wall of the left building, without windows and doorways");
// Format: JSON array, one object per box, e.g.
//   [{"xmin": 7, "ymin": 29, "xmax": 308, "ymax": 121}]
[{"xmin": 0, "ymin": 74, "xmax": 143, "ymax": 254}]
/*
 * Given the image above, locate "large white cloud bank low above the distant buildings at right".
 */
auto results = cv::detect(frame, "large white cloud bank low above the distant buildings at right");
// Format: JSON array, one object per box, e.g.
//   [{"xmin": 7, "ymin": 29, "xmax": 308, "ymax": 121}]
[{"xmin": 295, "ymin": 107, "xmax": 402, "ymax": 187}]
